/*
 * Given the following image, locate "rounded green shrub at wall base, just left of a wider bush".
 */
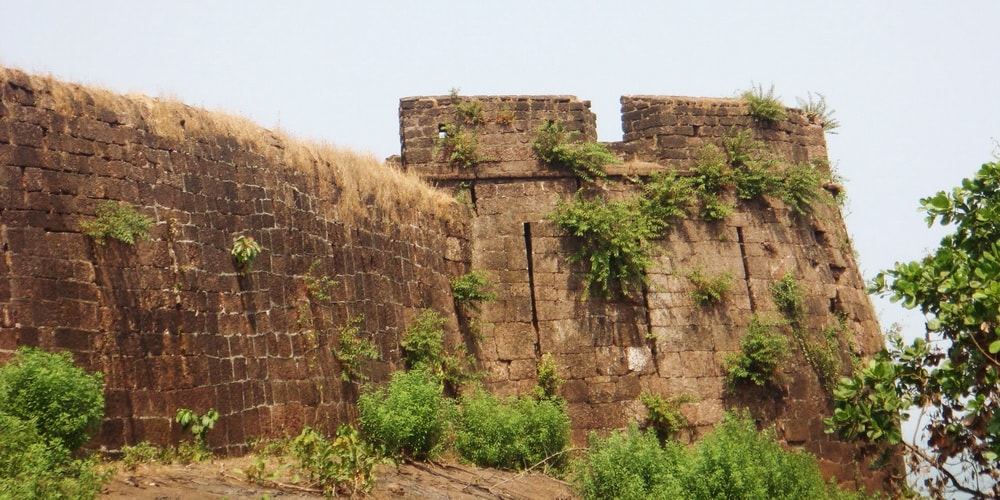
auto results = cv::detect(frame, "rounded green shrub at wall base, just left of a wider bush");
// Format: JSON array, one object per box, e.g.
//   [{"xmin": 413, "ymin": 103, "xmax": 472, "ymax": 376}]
[{"xmin": 358, "ymin": 370, "xmax": 448, "ymax": 460}]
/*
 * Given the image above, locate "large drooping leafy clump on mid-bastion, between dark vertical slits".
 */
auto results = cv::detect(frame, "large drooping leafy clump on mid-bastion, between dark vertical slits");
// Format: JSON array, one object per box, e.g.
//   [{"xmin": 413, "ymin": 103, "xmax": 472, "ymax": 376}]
[{"xmin": 549, "ymin": 196, "xmax": 662, "ymax": 297}]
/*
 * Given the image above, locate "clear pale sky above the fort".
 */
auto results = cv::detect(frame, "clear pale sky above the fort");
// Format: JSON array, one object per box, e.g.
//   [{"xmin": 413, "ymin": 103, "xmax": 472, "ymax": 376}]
[{"xmin": 0, "ymin": 0, "xmax": 1000, "ymax": 334}]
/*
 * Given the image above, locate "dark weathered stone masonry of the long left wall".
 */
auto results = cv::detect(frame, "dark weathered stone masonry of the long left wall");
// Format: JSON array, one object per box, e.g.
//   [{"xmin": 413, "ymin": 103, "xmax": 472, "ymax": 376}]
[{"xmin": 0, "ymin": 71, "xmax": 466, "ymax": 458}]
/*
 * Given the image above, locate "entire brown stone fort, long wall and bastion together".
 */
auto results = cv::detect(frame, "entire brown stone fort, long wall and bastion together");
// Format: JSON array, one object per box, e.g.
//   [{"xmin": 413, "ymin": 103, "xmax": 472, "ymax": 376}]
[{"xmin": 0, "ymin": 69, "xmax": 888, "ymax": 489}]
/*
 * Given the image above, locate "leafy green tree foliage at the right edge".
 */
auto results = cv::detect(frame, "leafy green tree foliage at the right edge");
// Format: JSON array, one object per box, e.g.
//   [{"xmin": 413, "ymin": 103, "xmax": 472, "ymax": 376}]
[{"xmin": 829, "ymin": 162, "xmax": 1000, "ymax": 495}]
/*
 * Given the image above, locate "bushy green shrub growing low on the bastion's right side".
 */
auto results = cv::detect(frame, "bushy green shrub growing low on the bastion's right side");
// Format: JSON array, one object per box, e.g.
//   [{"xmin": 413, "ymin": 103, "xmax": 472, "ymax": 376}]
[{"xmin": 725, "ymin": 315, "xmax": 790, "ymax": 387}]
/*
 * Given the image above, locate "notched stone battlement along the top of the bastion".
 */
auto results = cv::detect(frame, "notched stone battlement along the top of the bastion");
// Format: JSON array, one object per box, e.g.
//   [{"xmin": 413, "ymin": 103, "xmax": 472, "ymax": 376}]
[{"xmin": 399, "ymin": 95, "xmax": 826, "ymax": 181}]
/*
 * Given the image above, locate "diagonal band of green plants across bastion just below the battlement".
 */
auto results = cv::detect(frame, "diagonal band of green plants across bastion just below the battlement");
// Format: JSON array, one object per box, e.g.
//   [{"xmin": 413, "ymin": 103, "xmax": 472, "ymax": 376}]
[{"xmin": 552, "ymin": 130, "xmax": 828, "ymax": 305}]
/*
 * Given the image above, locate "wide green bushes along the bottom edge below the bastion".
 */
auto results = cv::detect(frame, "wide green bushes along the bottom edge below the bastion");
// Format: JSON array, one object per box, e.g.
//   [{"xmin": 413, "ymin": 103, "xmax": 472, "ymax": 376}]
[{"xmin": 572, "ymin": 413, "xmax": 865, "ymax": 500}]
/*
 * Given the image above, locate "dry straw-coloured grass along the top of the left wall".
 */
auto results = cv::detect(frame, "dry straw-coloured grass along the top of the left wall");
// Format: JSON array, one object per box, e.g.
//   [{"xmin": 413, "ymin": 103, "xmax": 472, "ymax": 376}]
[{"xmin": 0, "ymin": 67, "xmax": 458, "ymax": 220}]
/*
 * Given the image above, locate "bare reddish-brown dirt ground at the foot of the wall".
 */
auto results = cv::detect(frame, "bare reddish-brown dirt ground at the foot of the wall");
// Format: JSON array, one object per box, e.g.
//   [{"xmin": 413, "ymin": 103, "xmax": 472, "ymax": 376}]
[{"xmin": 100, "ymin": 457, "xmax": 574, "ymax": 500}]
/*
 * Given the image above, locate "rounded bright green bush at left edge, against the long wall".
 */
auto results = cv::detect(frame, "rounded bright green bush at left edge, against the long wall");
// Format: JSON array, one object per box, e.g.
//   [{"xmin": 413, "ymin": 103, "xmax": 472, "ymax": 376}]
[{"xmin": 0, "ymin": 347, "xmax": 104, "ymax": 451}]
